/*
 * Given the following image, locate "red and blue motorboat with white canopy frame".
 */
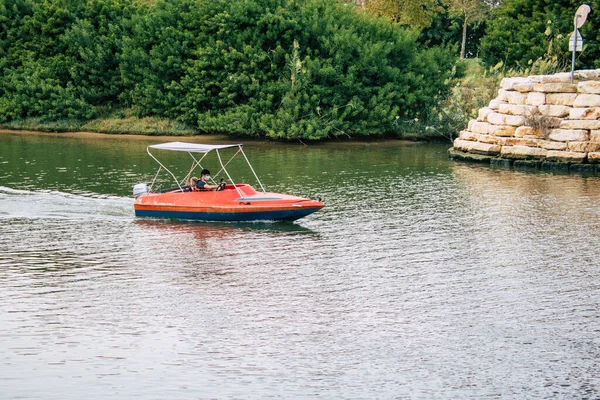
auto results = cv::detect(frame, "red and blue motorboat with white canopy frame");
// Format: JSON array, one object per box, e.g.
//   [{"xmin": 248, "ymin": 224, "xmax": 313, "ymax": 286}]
[{"xmin": 133, "ymin": 142, "xmax": 324, "ymax": 221}]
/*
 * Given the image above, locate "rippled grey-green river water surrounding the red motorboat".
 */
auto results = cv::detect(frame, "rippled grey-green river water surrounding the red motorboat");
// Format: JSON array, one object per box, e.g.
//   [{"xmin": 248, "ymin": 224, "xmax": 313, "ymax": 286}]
[{"xmin": 0, "ymin": 133, "xmax": 600, "ymax": 399}]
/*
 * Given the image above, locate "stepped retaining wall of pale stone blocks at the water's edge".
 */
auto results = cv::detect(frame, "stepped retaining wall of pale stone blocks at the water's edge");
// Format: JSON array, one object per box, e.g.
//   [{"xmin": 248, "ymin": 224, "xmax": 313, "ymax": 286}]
[{"xmin": 449, "ymin": 69, "xmax": 600, "ymax": 170}]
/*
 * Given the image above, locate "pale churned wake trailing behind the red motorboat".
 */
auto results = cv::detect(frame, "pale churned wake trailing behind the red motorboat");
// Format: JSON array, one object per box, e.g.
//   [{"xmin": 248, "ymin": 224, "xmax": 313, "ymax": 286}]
[{"xmin": 0, "ymin": 186, "xmax": 133, "ymax": 220}]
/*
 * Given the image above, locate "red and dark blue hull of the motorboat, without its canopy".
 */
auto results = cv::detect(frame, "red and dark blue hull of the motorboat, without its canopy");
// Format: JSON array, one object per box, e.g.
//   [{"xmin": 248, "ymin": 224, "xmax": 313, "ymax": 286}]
[{"xmin": 134, "ymin": 184, "xmax": 324, "ymax": 221}]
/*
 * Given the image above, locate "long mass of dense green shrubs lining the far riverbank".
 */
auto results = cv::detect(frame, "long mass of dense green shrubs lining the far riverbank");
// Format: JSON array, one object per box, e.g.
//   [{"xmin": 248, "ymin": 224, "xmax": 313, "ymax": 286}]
[{"xmin": 0, "ymin": 0, "xmax": 456, "ymax": 139}]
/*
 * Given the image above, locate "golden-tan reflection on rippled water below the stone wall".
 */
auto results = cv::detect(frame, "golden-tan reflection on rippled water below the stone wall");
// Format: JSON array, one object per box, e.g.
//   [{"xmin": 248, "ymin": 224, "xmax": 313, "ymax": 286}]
[{"xmin": 453, "ymin": 164, "xmax": 600, "ymax": 231}]
